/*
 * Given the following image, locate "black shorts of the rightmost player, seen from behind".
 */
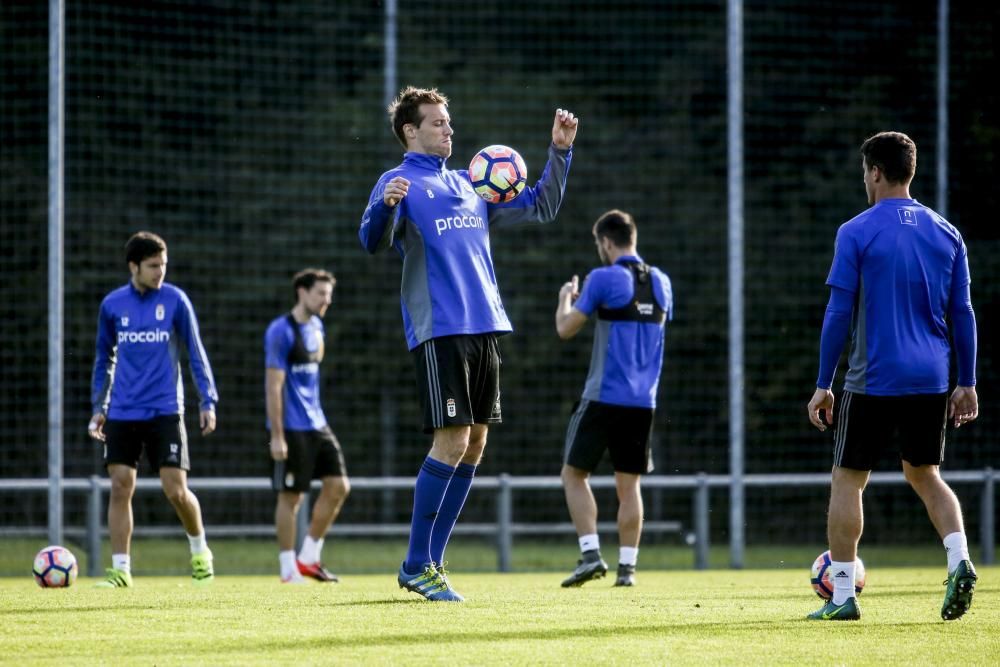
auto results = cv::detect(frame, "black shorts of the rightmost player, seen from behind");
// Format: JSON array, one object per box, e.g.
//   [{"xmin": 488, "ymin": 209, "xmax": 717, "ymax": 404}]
[{"xmin": 833, "ymin": 391, "xmax": 948, "ymax": 470}]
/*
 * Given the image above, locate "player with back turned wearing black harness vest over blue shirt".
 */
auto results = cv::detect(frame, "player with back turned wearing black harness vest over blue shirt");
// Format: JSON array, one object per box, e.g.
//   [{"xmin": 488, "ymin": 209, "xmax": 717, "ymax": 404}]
[{"xmin": 556, "ymin": 210, "xmax": 674, "ymax": 588}]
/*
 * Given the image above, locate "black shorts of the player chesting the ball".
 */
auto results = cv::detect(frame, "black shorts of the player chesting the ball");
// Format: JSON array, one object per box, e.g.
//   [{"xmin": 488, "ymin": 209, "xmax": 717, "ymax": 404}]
[{"xmin": 413, "ymin": 334, "xmax": 501, "ymax": 433}]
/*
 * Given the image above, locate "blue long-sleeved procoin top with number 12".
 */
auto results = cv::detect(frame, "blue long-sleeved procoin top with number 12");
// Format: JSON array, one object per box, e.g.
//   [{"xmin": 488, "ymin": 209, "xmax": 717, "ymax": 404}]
[{"xmin": 91, "ymin": 281, "xmax": 219, "ymax": 420}]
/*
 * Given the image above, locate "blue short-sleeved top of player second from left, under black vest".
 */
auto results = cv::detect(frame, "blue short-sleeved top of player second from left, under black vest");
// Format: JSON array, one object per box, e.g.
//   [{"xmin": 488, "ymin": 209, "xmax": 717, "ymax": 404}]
[{"xmin": 264, "ymin": 315, "xmax": 327, "ymax": 431}]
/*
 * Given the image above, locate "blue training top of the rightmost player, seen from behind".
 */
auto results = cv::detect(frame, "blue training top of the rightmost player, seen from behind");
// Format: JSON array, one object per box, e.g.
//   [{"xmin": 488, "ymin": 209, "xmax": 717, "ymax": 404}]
[{"xmin": 817, "ymin": 199, "xmax": 976, "ymax": 396}]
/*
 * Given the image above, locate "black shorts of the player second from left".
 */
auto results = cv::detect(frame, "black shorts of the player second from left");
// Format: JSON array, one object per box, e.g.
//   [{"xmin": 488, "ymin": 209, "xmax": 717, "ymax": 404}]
[{"xmin": 271, "ymin": 426, "xmax": 347, "ymax": 493}]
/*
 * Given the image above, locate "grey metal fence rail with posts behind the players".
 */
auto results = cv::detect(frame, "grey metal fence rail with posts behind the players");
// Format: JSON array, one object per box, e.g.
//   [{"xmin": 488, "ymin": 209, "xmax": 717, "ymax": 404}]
[{"xmin": 0, "ymin": 467, "xmax": 1000, "ymax": 576}]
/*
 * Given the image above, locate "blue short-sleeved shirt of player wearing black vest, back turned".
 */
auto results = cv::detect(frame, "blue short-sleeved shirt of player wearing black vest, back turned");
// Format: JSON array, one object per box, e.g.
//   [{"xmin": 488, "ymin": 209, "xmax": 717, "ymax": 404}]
[{"xmin": 573, "ymin": 255, "xmax": 674, "ymax": 408}]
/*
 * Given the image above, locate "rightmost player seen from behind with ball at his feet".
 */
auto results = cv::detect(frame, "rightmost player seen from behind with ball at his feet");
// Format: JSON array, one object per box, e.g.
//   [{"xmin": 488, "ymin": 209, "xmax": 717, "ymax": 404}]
[{"xmin": 807, "ymin": 132, "xmax": 979, "ymax": 621}]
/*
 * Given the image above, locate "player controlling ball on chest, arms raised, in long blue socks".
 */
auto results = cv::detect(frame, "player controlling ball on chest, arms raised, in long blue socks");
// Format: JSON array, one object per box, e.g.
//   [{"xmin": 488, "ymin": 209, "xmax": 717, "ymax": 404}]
[{"xmin": 358, "ymin": 87, "xmax": 578, "ymax": 601}]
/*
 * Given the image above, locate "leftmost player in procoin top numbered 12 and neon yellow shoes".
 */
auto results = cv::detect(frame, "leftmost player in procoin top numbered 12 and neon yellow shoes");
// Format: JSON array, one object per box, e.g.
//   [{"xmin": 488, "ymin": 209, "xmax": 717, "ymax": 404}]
[{"xmin": 87, "ymin": 232, "xmax": 219, "ymax": 588}]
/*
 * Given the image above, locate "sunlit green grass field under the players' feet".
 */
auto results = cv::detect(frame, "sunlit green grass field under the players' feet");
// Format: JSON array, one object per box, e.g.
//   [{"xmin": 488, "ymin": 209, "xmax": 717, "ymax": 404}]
[{"xmin": 0, "ymin": 565, "xmax": 1000, "ymax": 665}]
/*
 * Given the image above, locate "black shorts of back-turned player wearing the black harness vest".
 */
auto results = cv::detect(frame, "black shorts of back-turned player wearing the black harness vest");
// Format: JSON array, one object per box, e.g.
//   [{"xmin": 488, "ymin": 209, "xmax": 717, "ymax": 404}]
[{"xmin": 563, "ymin": 399, "xmax": 654, "ymax": 475}]
